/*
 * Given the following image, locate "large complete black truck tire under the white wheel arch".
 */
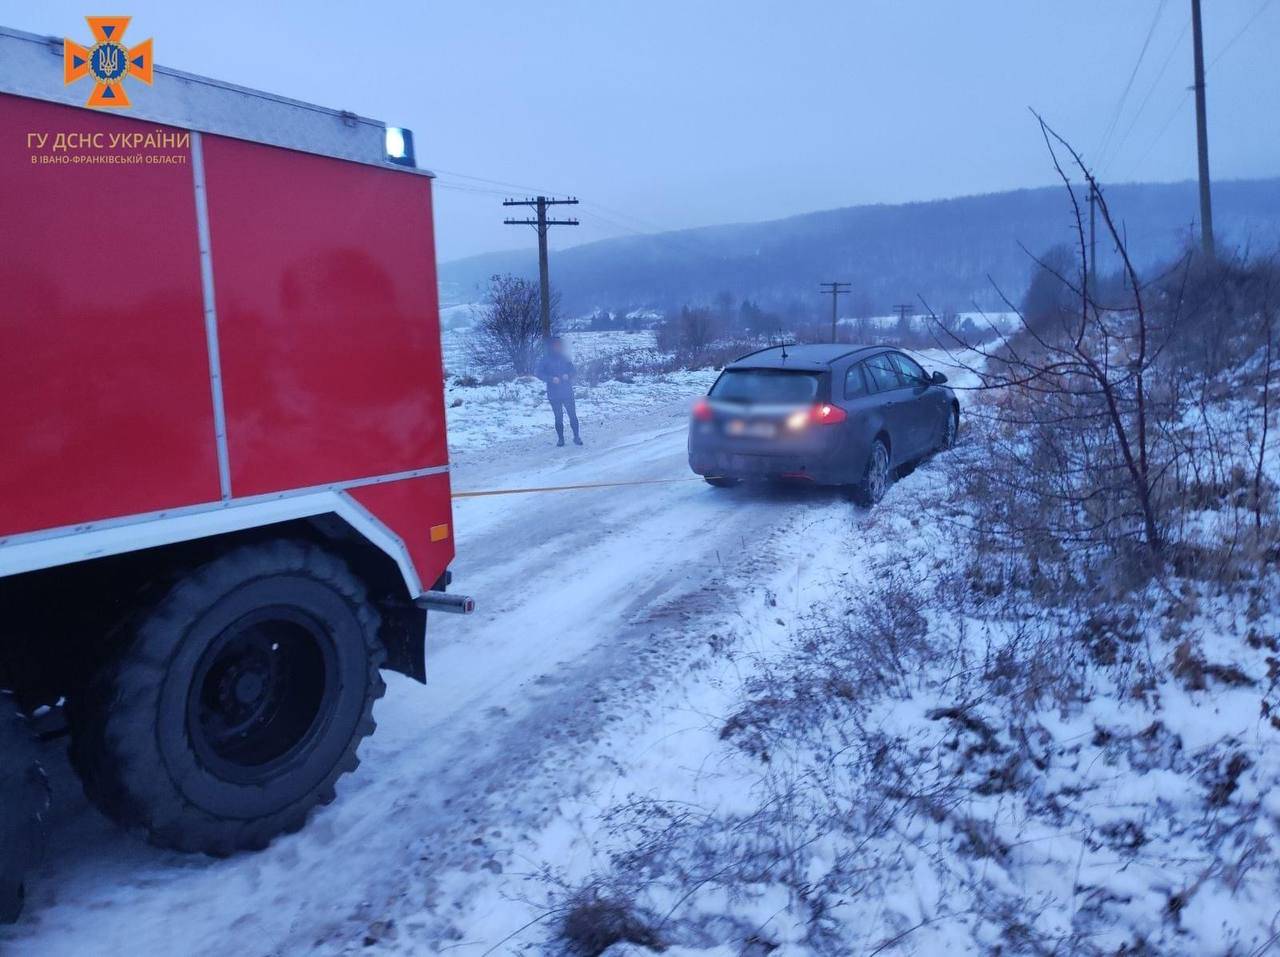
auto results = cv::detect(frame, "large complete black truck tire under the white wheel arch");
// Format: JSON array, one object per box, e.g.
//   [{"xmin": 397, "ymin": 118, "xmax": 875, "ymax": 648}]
[{"xmin": 69, "ymin": 541, "xmax": 385, "ymax": 856}]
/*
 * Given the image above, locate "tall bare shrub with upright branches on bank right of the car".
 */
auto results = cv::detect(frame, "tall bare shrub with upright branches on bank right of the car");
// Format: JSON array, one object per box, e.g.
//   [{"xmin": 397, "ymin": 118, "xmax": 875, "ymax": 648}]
[{"xmin": 934, "ymin": 120, "xmax": 1280, "ymax": 585}]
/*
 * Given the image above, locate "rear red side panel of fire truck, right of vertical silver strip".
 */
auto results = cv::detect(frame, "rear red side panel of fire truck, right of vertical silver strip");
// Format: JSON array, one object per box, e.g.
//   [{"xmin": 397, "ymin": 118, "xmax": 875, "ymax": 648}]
[{"xmin": 202, "ymin": 136, "xmax": 448, "ymax": 495}]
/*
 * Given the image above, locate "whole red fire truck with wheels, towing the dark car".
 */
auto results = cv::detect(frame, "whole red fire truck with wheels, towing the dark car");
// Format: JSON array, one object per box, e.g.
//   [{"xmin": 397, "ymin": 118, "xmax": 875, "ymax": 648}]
[{"xmin": 0, "ymin": 29, "xmax": 470, "ymax": 914}]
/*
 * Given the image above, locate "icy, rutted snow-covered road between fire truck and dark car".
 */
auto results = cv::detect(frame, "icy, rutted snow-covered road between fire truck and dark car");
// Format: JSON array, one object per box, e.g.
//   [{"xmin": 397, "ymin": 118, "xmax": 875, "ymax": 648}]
[{"xmin": 0, "ymin": 355, "xmax": 967, "ymax": 954}]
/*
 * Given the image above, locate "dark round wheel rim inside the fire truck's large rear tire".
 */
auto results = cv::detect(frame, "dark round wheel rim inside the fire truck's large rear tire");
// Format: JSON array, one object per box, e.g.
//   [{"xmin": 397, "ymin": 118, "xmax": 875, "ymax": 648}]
[{"xmin": 187, "ymin": 606, "xmax": 337, "ymax": 784}]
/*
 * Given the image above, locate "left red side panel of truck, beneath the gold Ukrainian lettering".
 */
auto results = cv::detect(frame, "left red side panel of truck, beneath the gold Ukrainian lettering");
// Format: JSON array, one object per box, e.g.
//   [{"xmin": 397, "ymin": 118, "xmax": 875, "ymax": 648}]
[{"xmin": 0, "ymin": 95, "xmax": 218, "ymax": 537}]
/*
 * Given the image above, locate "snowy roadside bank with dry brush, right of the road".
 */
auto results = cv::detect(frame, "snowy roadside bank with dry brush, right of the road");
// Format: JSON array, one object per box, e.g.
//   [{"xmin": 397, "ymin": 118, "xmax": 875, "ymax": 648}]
[{"xmin": 422, "ymin": 422, "xmax": 1280, "ymax": 957}]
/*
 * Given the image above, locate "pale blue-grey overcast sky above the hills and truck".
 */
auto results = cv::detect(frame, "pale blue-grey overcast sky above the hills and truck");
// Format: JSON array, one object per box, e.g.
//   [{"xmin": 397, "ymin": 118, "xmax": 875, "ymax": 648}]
[{"xmin": 10, "ymin": 0, "xmax": 1280, "ymax": 260}]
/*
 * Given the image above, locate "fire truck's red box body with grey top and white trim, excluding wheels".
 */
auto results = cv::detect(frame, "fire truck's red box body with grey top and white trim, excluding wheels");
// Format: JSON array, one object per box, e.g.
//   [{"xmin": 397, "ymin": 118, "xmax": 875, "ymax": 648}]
[{"xmin": 0, "ymin": 29, "xmax": 453, "ymax": 596}]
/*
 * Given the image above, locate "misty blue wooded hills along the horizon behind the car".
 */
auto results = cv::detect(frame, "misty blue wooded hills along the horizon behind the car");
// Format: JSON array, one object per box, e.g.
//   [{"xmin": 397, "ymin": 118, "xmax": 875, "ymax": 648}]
[{"xmin": 439, "ymin": 178, "xmax": 1280, "ymax": 315}]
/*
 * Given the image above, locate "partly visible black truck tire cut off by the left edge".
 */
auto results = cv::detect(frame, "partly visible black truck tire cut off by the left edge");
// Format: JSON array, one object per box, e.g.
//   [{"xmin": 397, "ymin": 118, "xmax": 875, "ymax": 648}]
[{"xmin": 0, "ymin": 695, "xmax": 49, "ymax": 924}]
